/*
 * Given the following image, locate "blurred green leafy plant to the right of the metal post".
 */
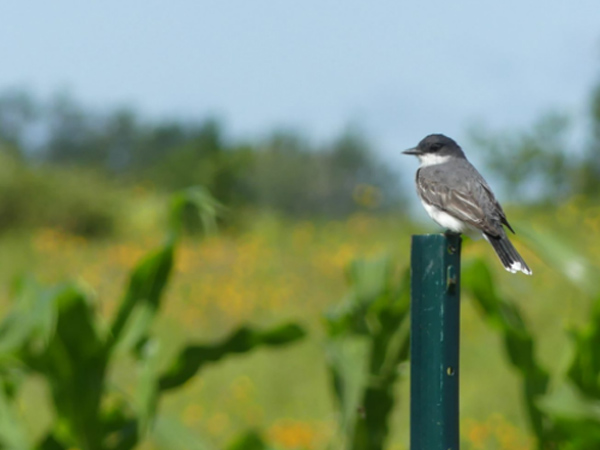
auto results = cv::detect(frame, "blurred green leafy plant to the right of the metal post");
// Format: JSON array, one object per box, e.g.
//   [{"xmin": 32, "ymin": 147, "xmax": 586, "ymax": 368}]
[{"xmin": 462, "ymin": 253, "xmax": 600, "ymax": 450}]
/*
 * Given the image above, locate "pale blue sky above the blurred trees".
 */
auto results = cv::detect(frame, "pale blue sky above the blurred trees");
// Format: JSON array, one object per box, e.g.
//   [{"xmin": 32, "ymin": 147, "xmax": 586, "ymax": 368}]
[{"xmin": 0, "ymin": 0, "xmax": 600, "ymax": 168}]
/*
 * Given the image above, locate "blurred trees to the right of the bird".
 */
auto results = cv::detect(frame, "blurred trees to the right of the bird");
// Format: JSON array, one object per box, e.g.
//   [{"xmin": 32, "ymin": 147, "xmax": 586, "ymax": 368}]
[{"xmin": 471, "ymin": 76, "xmax": 600, "ymax": 206}]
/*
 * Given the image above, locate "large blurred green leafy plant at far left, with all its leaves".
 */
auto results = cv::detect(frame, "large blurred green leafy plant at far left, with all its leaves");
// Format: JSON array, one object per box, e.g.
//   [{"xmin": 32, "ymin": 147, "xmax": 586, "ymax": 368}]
[{"xmin": 0, "ymin": 189, "xmax": 304, "ymax": 450}]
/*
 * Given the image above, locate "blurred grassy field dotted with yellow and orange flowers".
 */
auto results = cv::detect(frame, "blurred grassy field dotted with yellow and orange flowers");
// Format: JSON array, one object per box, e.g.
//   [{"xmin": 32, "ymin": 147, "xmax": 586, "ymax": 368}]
[{"xmin": 0, "ymin": 202, "xmax": 600, "ymax": 450}]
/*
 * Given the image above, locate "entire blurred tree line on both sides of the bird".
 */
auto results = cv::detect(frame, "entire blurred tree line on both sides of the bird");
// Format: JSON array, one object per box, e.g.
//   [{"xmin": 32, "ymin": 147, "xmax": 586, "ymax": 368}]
[{"xmin": 0, "ymin": 69, "xmax": 600, "ymax": 235}]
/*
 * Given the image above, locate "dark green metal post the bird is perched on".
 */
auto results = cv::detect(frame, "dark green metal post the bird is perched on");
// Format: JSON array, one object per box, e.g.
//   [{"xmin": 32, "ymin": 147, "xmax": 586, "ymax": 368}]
[{"xmin": 410, "ymin": 234, "xmax": 461, "ymax": 450}]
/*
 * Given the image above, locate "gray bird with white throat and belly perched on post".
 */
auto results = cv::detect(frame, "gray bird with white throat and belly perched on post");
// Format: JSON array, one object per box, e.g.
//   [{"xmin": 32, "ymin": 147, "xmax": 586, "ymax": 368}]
[{"xmin": 402, "ymin": 134, "xmax": 532, "ymax": 275}]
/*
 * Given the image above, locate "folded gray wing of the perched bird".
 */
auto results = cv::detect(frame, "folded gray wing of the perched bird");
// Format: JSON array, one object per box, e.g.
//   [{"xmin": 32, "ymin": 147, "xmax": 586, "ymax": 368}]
[{"xmin": 417, "ymin": 161, "xmax": 514, "ymax": 237}]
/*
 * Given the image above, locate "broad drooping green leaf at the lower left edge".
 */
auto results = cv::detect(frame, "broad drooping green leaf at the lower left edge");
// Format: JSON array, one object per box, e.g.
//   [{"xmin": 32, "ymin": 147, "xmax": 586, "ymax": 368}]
[{"xmin": 2, "ymin": 280, "xmax": 106, "ymax": 448}]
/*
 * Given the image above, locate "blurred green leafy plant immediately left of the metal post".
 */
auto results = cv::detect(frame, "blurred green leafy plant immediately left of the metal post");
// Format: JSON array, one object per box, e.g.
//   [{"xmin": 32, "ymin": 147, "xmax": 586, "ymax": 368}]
[{"xmin": 325, "ymin": 258, "xmax": 410, "ymax": 450}]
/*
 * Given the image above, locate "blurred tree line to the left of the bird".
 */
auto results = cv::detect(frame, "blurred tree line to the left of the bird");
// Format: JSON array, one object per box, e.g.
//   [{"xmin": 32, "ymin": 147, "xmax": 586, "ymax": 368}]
[{"xmin": 0, "ymin": 90, "xmax": 404, "ymax": 236}]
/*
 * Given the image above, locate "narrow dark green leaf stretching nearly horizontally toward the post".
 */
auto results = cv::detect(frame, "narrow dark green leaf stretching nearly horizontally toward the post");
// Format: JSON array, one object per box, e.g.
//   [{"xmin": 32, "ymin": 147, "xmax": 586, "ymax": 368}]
[{"xmin": 159, "ymin": 323, "xmax": 305, "ymax": 391}]
